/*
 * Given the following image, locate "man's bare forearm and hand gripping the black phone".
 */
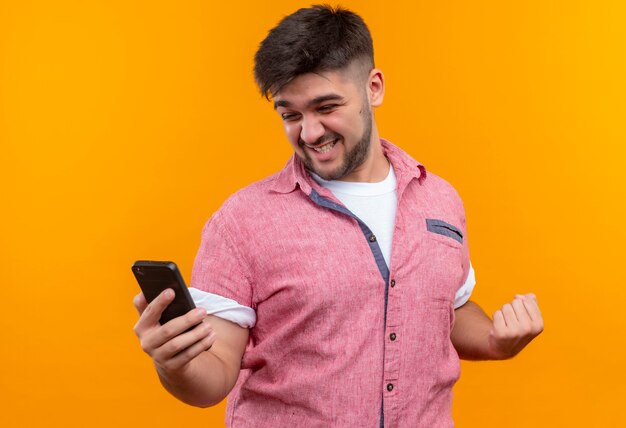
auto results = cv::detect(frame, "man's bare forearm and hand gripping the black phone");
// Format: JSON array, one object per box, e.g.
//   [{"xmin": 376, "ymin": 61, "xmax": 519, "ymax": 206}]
[{"xmin": 134, "ymin": 290, "xmax": 248, "ymax": 407}]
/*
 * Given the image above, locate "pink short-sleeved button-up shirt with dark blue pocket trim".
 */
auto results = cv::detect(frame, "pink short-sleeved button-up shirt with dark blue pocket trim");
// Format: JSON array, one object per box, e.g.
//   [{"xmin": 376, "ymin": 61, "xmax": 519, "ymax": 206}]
[{"xmin": 191, "ymin": 140, "xmax": 469, "ymax": 427}]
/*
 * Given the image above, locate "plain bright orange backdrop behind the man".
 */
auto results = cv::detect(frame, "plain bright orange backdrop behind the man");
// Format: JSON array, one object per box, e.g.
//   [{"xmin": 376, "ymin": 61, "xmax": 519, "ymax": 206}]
[{"xmin": 0, "ymin": 0, "xmax": 626, "ymax": 427}]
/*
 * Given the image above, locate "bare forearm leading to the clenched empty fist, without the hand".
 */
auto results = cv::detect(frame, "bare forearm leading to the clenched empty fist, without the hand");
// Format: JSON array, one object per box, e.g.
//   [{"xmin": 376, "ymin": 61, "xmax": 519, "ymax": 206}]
[{"xmin": 450, "ymin": 301, "xmax": 500, "ymax": 360}]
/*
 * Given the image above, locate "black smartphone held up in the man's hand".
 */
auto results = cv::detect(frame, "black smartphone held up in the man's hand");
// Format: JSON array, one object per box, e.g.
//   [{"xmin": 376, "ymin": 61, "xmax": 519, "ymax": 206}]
[{"xmin": 132, "ymin": 260, "xmax": 196, "ymax": 325}]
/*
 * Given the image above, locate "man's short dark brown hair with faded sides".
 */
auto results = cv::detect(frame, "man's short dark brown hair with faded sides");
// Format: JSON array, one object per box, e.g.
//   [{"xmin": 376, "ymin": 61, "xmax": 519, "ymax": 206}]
[{"xmin": 254, "ymin": 5, "xmax": 374, "ymax": 99}]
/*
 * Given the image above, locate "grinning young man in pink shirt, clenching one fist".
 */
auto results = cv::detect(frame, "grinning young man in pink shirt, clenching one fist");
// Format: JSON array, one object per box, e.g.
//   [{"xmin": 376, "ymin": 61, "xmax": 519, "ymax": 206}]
[{"xmin": 135, "ymin": 6, "xmax": 543, "ymax": 427}]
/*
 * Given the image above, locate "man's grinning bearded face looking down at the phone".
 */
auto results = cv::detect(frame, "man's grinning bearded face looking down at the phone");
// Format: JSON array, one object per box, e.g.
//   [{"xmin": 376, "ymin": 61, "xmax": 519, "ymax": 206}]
[{"xmin": 274, "ymin": 69, "xmax": 372, "ymax": 181}]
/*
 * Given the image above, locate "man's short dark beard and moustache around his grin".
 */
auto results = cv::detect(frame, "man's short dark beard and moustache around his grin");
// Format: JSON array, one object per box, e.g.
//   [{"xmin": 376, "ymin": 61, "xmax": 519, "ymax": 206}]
[{"xmin": 298, "ymin": 103, "xmax": 372, "ymax": 181}]
